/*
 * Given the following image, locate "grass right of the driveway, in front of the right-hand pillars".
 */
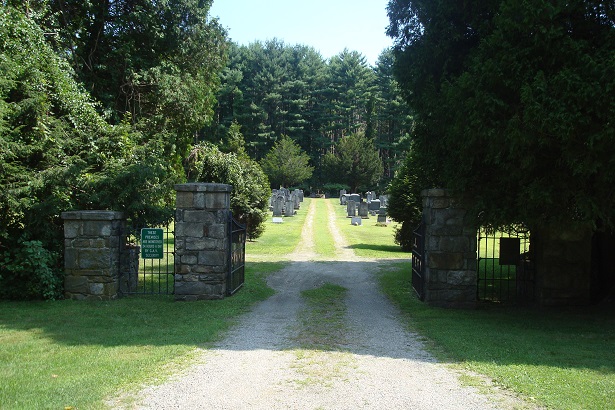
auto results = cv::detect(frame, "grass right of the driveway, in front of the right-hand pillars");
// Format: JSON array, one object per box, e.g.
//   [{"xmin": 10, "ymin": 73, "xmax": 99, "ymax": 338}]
[{"xmin": 380, "ymin": 263, "xmax": 615, "ymax": 410}]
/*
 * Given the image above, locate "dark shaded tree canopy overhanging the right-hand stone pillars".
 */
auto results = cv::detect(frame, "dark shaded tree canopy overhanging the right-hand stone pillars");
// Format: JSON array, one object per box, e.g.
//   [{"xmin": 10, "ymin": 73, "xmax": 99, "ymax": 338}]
[{"xmin": 388, "ymin": 0, "xmax": 615, "ymax": 226}]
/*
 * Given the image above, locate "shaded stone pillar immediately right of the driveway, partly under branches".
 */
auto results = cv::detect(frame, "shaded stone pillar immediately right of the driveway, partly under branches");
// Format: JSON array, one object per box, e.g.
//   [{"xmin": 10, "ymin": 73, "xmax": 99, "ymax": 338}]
[{"xmin": 421, "ymin": 189, "xmax": 477, "ymax": 307}]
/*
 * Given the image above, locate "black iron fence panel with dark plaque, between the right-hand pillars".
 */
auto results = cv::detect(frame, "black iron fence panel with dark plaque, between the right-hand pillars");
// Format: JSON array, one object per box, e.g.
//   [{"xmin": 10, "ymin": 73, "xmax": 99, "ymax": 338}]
[{"xmin": 476, "ymin": 226, "xmax": 536, "ymax": 304}]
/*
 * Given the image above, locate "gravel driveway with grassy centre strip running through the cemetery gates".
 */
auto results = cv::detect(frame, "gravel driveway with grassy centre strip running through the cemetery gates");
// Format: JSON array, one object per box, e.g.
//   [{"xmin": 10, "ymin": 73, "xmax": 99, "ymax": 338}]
[{"xmin": 121, "ymin": 200, "xmax": 526, "ymax": 410}]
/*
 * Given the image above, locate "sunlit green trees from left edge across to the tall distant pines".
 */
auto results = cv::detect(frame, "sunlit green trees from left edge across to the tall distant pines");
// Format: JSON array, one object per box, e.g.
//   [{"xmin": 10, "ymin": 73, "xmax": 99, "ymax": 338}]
[{"xmin": 0, "ymin": 0, "xmax": 412, "ymax": 299}]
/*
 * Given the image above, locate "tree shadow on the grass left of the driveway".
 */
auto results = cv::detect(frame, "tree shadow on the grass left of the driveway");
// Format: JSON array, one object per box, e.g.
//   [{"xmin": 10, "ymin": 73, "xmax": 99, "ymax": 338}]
[{"xmin": 0, "ymin": 262, "xmax": 283, "ymax": 348}]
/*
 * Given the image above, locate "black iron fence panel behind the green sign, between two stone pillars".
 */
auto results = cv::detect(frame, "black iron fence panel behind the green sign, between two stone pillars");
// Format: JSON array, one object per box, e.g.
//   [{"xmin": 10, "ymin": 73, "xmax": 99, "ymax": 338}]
[{"xmin": 119, "ymin": 225, "xmax": 175, "ymax": 295}]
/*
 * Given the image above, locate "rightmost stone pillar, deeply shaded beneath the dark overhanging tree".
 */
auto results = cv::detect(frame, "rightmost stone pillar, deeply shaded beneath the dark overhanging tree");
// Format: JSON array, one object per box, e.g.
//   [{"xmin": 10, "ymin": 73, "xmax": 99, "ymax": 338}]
[{"xmin": 531, "ymin": 222, "xmax": 593, "ymax": 306}]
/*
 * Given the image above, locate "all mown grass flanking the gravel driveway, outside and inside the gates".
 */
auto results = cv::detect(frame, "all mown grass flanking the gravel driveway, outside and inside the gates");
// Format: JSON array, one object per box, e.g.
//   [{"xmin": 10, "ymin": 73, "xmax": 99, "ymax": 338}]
[{"xmin": 0, "ymin": 198, "xmax": 615, "ymax": 410}]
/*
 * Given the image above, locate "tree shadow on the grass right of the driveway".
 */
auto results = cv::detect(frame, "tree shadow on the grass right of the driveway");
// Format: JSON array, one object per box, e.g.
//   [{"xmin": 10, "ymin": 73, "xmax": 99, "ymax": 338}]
[{"xmin": 380, "ymin": 264, "xmax": 615, "ymax": 374}]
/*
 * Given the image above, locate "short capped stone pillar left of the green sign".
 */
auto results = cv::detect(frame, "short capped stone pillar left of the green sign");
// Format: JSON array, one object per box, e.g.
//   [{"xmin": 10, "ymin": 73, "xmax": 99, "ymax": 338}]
[{"xmin": 62, "ymin": 211, "xmax": 124, "ymax": 300}]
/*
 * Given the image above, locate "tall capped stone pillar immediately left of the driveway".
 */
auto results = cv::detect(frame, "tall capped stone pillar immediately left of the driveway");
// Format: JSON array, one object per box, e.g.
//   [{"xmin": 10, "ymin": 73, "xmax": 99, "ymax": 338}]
[{"xmin": 175, "ymin": 183, "xmax": 232, "ymax": 301}]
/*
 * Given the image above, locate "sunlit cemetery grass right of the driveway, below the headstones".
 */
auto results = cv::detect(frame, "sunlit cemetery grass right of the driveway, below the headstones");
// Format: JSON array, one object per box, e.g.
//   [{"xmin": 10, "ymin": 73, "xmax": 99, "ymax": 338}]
[{"xmin": 328, "ymin": 198, "xmax": 410, "ymax": 259}]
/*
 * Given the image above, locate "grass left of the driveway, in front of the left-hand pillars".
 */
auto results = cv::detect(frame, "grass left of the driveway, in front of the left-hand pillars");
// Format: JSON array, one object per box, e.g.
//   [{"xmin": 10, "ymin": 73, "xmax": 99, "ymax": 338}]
[{"xmin": 0, "ymin": 263, "xmax": 282, "ymax": 409}]
